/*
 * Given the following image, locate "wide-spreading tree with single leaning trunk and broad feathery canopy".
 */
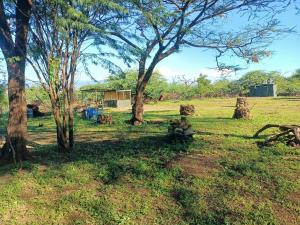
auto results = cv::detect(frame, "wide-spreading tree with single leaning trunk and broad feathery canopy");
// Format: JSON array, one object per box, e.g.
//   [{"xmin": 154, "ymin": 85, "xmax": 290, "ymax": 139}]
[{"xmin": 110, "ymin": 0, "xmax": 286, "ymax": 125}]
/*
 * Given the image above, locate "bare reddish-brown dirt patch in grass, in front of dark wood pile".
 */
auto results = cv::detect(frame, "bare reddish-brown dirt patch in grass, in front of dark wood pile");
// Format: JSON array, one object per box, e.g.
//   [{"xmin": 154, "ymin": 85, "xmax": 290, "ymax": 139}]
[{"xmin": 167, "ymin": 154, "xmax": 221, "ymax": 178}]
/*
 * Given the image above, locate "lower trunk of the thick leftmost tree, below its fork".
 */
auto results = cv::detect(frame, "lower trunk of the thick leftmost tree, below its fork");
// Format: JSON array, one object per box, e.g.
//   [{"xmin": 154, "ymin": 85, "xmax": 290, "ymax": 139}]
[{"xmin": 1, "ymin": 62, "xmax": 30, "ymax": 163}]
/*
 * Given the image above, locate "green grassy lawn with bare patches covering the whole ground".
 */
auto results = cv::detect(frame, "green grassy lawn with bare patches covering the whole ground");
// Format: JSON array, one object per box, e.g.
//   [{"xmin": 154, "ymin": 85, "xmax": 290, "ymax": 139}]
[{"xmin": 0, "ymin": 97, "xmax": 300, "ymax": 225}]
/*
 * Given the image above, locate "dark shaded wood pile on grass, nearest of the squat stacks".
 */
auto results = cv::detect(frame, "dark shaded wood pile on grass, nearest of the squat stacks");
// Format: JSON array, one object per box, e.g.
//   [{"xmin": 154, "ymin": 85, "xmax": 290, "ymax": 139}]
[{"xmin": 168, "ymin": 117, "xmax": 196, "ymax": 141}]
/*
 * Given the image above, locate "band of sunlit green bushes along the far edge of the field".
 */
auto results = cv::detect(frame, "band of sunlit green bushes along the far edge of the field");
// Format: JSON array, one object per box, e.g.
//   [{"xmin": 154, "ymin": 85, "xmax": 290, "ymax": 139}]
[{"xmin": 82, "ymin": 70, "xmax": 300, "ymax": 99}]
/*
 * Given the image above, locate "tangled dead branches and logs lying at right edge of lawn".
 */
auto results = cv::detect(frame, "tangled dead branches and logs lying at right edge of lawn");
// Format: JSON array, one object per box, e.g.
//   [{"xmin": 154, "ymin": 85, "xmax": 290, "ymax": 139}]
[{"xmin": 253, "ymin": 124, "xmax": 300, "ymax": 147}]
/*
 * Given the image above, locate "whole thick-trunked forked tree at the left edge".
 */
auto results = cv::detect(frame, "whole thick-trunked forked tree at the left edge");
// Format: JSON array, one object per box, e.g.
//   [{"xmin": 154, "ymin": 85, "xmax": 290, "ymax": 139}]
[{"xmin": 0, "ymin": 0, "xmax": 32, "ymax": 163}]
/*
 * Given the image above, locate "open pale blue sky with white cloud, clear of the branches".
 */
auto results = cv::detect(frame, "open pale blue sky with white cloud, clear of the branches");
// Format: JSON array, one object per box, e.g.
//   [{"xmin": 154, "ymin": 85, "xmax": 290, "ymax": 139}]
[{"xmin": 77, "ymin": 6, "xmax": 300, "ymax": 85}]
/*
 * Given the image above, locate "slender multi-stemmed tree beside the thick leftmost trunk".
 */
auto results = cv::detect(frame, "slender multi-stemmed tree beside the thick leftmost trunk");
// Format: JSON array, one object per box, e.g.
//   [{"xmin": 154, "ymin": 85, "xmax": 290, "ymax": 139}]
[{"xmin": 28, "ymin": 0, "xmax": 119, "ymax": 152}]
